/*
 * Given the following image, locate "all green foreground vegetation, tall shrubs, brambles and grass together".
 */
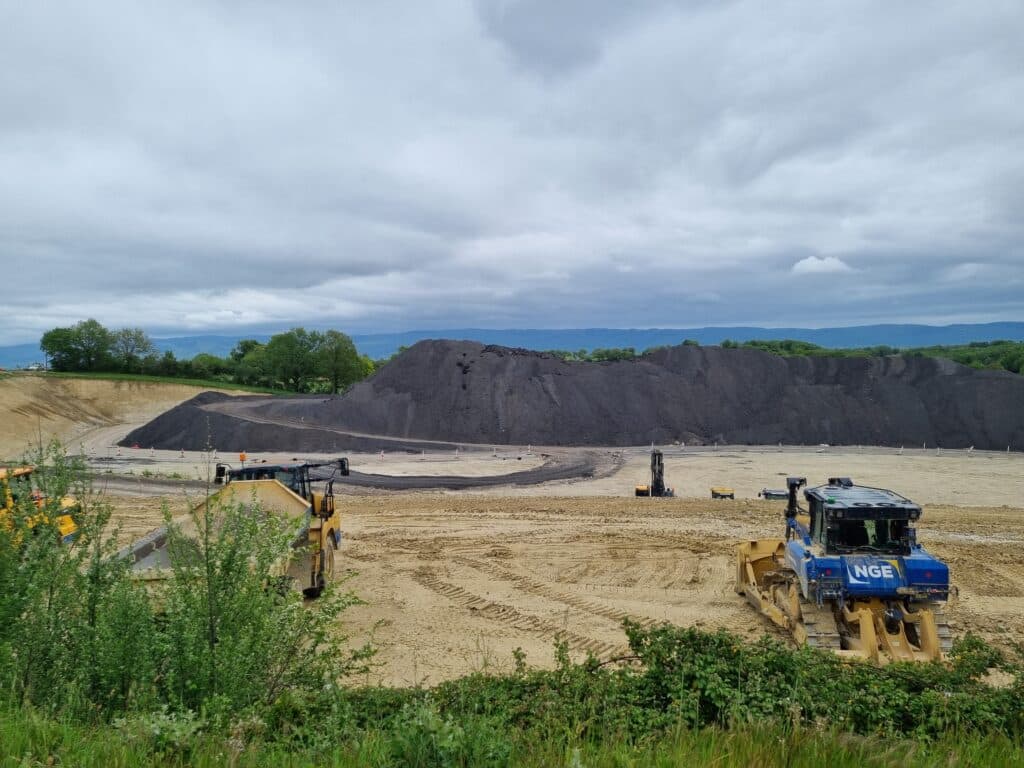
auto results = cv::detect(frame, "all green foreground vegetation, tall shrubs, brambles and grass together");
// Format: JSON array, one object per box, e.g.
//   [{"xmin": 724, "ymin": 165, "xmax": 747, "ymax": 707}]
[{"xmin": 0, "ymin": 444, "xmax": 1024, "ymax": 768}]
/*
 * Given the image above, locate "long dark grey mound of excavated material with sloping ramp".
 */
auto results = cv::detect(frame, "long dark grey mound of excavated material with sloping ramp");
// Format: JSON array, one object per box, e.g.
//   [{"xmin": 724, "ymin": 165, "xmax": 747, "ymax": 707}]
[{"xmin": 124, "ymin": 341, "xmax": 1024, "ymax": 451}]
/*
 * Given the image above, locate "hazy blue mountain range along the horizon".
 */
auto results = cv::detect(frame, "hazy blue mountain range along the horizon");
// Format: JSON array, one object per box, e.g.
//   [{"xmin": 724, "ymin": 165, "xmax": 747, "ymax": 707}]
[{"xmin": 0, "ymin": 323, "xmax": 1024, "ymax": 368}]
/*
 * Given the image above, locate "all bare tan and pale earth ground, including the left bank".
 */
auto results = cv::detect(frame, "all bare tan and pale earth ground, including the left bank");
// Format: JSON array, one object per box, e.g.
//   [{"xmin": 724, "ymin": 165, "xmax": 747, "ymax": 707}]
[{"xmin": 8, "ymin": 377, "xmax": 1024, "ymax": 685}]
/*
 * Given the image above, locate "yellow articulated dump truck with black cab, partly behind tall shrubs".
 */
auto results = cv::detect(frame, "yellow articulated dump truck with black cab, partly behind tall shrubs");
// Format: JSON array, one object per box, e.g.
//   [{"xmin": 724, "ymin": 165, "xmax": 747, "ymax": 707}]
[{"xmin": 122, "ymin": 459, "xmax": 349, "ymax": 598}]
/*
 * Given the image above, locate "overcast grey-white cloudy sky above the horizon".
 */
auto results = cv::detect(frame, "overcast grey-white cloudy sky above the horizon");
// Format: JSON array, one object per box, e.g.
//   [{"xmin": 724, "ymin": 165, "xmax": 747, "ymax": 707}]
[{"xmin": 0, "ymin": 0, "xmax": 1024, "ymax": 343}]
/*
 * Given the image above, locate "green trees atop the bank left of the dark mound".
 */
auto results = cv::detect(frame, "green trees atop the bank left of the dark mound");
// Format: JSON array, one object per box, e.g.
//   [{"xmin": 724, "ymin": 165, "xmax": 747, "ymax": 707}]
[{"xmin": 39, "ymin": 318, "xmax": 375, "ymax": 393}]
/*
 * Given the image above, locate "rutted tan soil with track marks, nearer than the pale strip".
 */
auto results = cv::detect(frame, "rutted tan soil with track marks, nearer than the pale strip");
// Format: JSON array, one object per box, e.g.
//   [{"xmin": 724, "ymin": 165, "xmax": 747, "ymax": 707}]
[{"xmin": 111, "ymin": 493, "xmax": 1024, "ymax": 685}]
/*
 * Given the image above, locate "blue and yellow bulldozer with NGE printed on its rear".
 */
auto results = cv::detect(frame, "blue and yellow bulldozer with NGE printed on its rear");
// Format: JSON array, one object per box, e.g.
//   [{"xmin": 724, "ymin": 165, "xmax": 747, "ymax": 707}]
[{"xmin": 736, "ymin": 477, "xmax": 952, "ymax": 664}]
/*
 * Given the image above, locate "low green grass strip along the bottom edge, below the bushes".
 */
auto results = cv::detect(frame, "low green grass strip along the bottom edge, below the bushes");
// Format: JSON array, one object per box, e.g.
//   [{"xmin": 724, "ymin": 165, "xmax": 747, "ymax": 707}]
[{"xmin": 0, "ymin": 709, "xmax": 1024, "ymax": 768}]
